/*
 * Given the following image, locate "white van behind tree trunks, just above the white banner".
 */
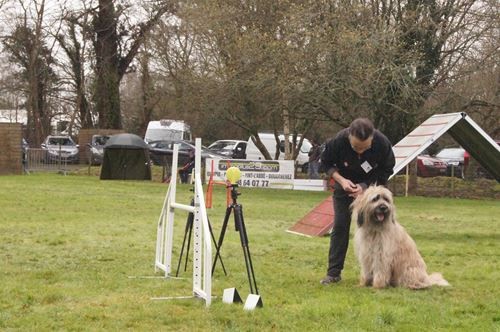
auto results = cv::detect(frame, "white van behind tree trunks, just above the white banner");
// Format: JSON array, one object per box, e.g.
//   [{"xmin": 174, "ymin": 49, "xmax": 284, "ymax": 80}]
[{"xmin": 246, "ymin": 133, "xmax": 312, "ymax": 170}]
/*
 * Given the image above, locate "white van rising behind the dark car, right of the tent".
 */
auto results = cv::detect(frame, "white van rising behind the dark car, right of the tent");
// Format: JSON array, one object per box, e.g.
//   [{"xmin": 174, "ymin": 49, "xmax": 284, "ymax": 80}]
[{"xmin": 144, "ymin": 120, "xmax": 192, "ymax": 143}]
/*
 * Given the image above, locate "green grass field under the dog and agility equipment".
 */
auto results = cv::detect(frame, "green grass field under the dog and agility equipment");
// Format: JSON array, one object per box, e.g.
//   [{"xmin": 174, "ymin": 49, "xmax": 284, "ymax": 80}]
[{"xmin": 0, "ymin": 174, "xmax": 500, "ymax": 331}]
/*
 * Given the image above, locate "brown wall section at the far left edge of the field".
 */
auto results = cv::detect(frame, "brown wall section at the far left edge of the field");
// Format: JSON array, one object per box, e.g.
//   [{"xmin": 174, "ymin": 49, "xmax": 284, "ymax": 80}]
[{"xmin": 0, "ymin": 123, "xmax": 23, "ymax": 175}]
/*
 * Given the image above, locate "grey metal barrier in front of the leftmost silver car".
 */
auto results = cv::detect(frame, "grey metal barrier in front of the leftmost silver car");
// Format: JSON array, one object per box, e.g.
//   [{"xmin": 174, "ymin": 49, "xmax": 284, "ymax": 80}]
[{"xmin": 23, "ymin": 148, "xmax": 80, "ymax": 175}]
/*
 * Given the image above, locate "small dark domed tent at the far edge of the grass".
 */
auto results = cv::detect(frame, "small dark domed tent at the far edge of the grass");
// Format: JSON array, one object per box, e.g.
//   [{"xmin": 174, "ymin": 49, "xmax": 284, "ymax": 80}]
[{"xmin": 101, "ymin": 134, "xmax": 151, "ymax": 180}]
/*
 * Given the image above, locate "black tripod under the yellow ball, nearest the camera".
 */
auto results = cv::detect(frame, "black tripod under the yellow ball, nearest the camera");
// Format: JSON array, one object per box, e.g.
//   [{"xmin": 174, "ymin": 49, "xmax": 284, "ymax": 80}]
[{"xmin": 212, "ymin": 184, "xmax": 259, "ymax": 295}]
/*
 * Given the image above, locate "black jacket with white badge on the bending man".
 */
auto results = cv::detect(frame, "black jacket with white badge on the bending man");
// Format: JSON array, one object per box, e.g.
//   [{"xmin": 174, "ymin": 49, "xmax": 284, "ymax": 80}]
[{"xmin": 321, "ymin": 128, "xmax": 396, "ymax": 188}]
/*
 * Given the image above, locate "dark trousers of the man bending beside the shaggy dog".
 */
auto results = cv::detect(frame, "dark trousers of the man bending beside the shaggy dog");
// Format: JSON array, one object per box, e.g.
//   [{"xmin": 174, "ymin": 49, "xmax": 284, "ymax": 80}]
[{"xmin": 327, "ymin": 183, "xmax": 353, "ymax": 277}]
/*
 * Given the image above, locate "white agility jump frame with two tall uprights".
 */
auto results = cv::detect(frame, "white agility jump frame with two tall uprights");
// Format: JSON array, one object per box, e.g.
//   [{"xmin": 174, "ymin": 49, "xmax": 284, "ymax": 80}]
[{"xmin": 155, "ymin": 138, "xmax": 212, "ymax": 306}]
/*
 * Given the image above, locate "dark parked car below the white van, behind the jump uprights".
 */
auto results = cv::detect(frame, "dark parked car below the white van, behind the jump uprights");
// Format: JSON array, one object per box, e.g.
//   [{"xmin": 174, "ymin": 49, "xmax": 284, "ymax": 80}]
[{"xmin": 149, "ymin": 141, "xmax": 227, "ymax": 166}]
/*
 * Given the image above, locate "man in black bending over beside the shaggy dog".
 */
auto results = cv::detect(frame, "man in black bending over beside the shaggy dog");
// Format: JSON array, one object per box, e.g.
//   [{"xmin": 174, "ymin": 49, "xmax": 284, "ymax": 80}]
[{"xmin": 321, "ymin": 118, "xmax": 395, "ymax": 285}]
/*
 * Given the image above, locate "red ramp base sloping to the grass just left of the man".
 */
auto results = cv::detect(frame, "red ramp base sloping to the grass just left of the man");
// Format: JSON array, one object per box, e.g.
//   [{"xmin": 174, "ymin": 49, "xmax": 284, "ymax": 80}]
[{"xmin": 287, "ymin": 196, "xmax": 334, "ymax": 236}]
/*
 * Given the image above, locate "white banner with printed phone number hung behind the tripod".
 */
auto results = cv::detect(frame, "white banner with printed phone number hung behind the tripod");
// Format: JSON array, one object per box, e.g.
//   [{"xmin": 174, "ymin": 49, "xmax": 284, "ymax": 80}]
[{"xmin": 205, "ymin": 159, "xmax": 295, "ymax": 189}]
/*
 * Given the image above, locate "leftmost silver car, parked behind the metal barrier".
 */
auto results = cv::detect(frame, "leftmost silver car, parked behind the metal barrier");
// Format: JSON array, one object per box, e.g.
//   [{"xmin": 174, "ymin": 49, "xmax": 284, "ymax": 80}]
[{"xmin": 42, "ymin": 135, "xmax": 79, "ymax": 163}]
